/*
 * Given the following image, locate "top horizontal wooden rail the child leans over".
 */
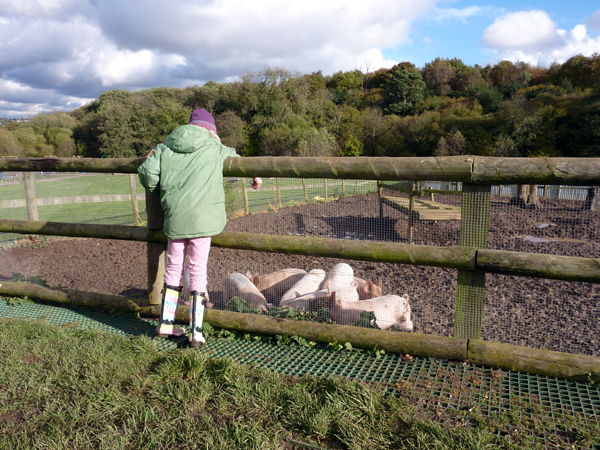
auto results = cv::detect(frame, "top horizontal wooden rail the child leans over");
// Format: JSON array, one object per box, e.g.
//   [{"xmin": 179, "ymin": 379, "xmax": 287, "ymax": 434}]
[{"xmin": 0, "ymin": 155, "xmax": 600, "ymax": 186}]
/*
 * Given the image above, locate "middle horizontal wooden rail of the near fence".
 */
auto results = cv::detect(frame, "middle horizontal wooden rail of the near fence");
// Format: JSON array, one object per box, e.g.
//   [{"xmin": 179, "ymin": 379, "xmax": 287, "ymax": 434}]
[{"xmin": 0, "ymin": 219, "xmax": 600, "ymax": 283}]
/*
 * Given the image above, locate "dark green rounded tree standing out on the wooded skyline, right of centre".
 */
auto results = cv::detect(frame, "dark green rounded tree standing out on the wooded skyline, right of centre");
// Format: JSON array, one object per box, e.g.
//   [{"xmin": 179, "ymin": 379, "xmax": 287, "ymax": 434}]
[{"xmin": 385, "ymin": 69, "xmax": 426, "ymax": 116}]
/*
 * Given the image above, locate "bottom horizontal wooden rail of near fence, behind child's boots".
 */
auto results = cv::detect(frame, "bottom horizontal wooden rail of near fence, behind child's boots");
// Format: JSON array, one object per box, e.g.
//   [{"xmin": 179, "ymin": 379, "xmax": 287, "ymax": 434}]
[{"xmin": 0, "ymin": 281, "xmax": 600, "ymax": 383}]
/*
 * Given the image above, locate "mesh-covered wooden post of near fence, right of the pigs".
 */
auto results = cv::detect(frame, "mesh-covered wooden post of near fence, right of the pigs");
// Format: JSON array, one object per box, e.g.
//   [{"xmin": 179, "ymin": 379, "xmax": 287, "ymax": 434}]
[{"xmin": 454, "ymin": 183, "xmax": 491, "ymax": 339}]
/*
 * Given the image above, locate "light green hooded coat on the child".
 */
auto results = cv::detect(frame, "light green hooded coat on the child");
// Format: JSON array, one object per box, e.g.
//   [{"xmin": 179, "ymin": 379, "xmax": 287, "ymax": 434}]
[{"xmin": 138, "ymin": 125, "xmax": 239, "ymax": 239}]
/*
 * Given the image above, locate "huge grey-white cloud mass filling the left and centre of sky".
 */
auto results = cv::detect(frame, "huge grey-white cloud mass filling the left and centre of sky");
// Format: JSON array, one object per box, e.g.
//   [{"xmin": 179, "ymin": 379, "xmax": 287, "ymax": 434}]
[{"xmin": 0, "ymin": 0, "xmax": 442, "ymax": 117}]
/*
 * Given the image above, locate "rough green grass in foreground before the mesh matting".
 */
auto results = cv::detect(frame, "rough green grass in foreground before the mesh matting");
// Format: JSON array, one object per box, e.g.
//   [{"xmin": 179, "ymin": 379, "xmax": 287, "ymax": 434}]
[{"xmin": 0, "ymin": 319, "xmax": 527, "ymax": 450}]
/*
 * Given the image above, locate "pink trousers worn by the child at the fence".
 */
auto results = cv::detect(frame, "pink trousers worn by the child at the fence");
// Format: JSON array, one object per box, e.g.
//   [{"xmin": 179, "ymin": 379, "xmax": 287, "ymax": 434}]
[{"xmin": 165, "ymin": 236, "xmax": 210, "ymax": 292}]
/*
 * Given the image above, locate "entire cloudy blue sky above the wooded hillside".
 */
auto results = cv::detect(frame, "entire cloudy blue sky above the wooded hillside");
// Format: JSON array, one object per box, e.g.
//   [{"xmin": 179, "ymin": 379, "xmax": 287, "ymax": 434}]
[{"xmin": 0, "ymin": 0, "xmax": 600, "ymax": 118}]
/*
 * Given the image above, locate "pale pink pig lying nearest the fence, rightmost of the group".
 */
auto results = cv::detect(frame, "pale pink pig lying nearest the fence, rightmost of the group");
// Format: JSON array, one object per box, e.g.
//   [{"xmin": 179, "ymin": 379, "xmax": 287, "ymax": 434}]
[{"xmin": 329, "ymin": 291, "xmax": 413, "ymax": 332}]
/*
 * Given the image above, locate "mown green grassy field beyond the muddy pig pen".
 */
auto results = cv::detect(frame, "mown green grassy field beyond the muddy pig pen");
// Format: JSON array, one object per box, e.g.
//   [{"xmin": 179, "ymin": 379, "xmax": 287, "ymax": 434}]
[{"xmin": 0, "ymin": 174, "xmax": 377, "ymax": 242}]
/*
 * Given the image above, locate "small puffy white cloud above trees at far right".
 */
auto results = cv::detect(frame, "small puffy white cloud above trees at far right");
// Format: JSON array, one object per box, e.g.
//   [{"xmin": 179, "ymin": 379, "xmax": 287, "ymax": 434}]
[{"xmin": 481, "ymin": 11, "xmax": 600, "ymax": 66}]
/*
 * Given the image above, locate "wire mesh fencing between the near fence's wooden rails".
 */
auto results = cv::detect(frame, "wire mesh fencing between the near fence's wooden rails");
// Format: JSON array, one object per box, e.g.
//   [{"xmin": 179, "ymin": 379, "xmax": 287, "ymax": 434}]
[{"xmin": 0, "ymin": 173, "xmax": 600, "ymax": 356}]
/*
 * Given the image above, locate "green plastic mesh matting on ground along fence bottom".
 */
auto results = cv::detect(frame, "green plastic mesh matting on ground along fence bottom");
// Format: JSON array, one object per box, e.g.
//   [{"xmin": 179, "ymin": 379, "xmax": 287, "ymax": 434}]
[{"xmin": 0, "ymin": 300, "xmax": 600, "ymax": 450}]
